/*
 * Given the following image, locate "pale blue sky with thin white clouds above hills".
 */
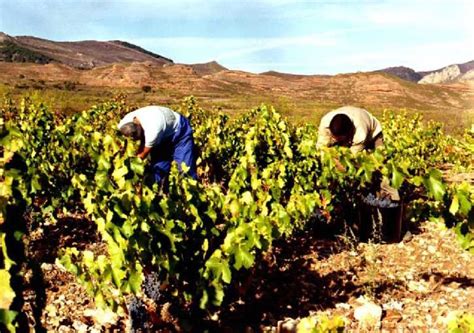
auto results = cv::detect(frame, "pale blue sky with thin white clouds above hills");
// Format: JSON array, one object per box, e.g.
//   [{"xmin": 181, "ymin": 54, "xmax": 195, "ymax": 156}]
[{"xmin": 0, "ymin": 0, "xmax": 474, "ymax": 74}]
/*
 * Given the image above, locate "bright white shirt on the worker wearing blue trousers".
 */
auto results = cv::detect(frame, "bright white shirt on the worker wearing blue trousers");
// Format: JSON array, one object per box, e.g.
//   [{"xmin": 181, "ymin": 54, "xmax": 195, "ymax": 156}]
[{"xmin": 118, "ymin": 105, "xmax": 181, "ymax": 147}]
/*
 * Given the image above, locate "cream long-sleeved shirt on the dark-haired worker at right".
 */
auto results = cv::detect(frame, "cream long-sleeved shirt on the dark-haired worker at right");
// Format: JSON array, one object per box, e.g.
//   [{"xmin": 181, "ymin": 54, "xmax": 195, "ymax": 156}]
[{"xmin": 316, "ymin": 106, "xmax": 382, "ymax": 153}]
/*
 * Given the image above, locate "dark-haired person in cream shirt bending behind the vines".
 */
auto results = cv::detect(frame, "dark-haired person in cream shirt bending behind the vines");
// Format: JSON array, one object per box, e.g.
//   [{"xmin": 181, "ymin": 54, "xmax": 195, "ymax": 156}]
[{"xmin": 316, "ymin": 106, "xmax": 400, "ymax": 201}]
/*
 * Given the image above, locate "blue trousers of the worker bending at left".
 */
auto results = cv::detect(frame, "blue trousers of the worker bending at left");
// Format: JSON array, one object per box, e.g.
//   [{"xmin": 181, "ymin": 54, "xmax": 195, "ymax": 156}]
[{"xmin": 151, "ymin": 116, "xmax": 197, "ymax": 183}]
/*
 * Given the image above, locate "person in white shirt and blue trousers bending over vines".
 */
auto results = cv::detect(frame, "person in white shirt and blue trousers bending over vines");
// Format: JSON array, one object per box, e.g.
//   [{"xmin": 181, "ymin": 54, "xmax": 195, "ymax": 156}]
[{"xmin": 118, "ymin": 105, "xmax": 197, "ymax": 182}]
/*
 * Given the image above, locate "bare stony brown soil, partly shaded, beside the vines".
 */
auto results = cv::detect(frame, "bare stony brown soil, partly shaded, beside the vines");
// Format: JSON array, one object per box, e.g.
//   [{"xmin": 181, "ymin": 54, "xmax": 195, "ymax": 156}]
[{"xmin": 20, "ymin": 218, "xmax": 474, "ymax": 332}]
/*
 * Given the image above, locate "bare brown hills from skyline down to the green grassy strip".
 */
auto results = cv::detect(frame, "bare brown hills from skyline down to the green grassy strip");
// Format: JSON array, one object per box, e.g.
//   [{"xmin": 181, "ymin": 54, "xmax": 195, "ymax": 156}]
[{"xmin": 0, "ymin": 34, "xmax": 474, "ymax": 115}]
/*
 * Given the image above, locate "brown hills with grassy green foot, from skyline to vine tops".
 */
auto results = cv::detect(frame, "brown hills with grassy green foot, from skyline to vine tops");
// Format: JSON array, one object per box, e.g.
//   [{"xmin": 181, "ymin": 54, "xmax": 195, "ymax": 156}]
[{"xmin": 0, "ymin": 34, "xmax": 474, "ymax": 134}]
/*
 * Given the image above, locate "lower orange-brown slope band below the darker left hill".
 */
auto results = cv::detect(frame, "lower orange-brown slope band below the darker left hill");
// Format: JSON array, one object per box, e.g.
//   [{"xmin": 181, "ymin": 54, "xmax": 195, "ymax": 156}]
[{"xmin": 0, "ymin": 62, "xmax": 474, "ymax": 110}]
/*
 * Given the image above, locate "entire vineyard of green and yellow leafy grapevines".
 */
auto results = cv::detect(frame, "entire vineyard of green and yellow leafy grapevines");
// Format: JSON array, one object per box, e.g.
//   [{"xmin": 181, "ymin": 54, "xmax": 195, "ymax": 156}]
[{"xmin": 0, "ymin": 98, "xmax": 474, "ymax": 332}]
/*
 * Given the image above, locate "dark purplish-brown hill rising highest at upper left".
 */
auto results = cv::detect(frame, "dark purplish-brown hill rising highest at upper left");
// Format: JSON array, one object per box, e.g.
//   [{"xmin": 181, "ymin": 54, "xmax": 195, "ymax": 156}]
[{"xmin": 0, "ymin": 33, "xmax": 173, "ymax": 69}]
